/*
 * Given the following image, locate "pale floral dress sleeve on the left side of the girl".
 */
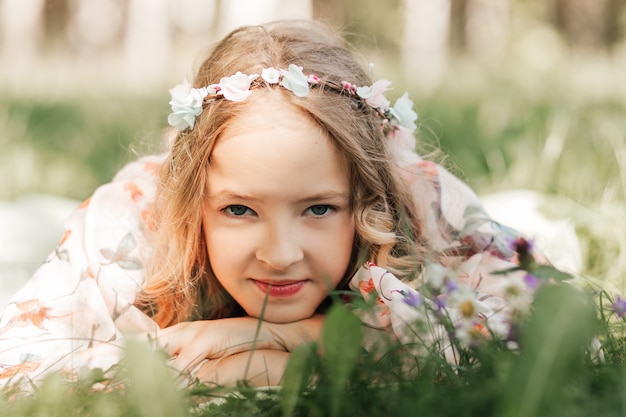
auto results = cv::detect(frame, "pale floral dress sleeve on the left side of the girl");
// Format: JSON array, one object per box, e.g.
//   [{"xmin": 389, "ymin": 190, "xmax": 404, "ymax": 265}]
[{"xmin": 0, "ymin": 157, "xmax": 159, "ymax": 384}]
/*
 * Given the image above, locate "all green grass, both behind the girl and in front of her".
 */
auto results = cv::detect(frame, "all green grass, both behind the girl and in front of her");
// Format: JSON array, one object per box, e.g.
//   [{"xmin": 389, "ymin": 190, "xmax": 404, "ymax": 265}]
[{"xmin": 0, "ymin": 57, "xmax": 626, "ymax": 417}]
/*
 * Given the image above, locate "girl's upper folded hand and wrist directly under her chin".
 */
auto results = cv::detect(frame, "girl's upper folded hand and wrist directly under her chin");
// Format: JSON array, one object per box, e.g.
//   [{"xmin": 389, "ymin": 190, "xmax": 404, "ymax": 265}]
[{"xmin": 157, "ymin": 315, "xmax": 323, "ymax": 372}]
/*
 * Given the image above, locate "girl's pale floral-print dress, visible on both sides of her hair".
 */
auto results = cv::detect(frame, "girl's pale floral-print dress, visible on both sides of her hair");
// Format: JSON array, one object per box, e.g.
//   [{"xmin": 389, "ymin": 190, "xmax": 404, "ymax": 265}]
[{"xmin": 0, "ymin": 154, "xmax": 528, "ymax": 384}]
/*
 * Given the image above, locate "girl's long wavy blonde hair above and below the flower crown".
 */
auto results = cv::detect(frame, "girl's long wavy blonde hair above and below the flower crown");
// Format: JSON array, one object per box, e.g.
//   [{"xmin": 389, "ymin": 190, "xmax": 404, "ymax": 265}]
[{"xmin": 142, "ymin": 21, "xmax": 422, "ymax": 326}]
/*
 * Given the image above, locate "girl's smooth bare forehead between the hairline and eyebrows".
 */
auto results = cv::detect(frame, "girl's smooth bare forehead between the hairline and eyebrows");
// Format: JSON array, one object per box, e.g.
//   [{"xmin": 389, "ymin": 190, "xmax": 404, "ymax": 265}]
[{"xmin": 209, "ymin": 96, "xmax": 350, "ymax": 194}]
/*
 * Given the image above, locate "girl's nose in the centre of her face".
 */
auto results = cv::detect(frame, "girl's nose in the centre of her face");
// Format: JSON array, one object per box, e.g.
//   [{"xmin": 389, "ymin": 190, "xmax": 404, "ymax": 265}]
[{"xmin": 256, "ymin": 221, "xmax": 304, "ymax": 271}]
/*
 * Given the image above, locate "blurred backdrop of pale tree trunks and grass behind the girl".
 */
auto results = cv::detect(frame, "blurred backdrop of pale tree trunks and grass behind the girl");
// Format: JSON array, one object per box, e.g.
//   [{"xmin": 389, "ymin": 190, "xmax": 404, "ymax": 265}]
[{"xmin": 0, "ymin": 0, "xmax": 626, "ymax": 300}]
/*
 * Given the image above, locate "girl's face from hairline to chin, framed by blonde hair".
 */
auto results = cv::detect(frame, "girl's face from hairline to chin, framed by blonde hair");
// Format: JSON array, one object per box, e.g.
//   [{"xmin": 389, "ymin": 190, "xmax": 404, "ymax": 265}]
[{"xmin": 203, "ymin": 98, "xmax": 355, "ymax": 323}]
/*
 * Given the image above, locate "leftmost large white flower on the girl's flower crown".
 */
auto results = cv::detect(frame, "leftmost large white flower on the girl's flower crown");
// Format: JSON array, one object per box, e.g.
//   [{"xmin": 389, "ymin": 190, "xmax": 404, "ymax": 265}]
[{"xmin": 167, "ymin": 80, "xmax": 208, "ymax": 131}]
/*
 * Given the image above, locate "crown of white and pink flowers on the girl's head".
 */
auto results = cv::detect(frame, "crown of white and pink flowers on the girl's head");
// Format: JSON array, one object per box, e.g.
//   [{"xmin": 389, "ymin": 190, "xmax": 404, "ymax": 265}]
[{"xmin": 167, "ymin": 64, "xmax": 417, "ymax": 155}]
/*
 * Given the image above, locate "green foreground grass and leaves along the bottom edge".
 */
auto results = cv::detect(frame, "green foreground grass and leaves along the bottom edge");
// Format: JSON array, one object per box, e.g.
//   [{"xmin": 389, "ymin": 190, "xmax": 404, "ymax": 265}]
[{"xmin": 0, "ymin": 285, "xmax": 626, "ymax": 417}]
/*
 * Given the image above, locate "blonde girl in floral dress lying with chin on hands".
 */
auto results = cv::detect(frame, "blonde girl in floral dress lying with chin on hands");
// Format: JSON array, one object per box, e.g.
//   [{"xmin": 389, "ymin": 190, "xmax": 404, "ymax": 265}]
[{"xmin": 0, "ymin": 22, "xmax": 532, "ymax": 384}]
